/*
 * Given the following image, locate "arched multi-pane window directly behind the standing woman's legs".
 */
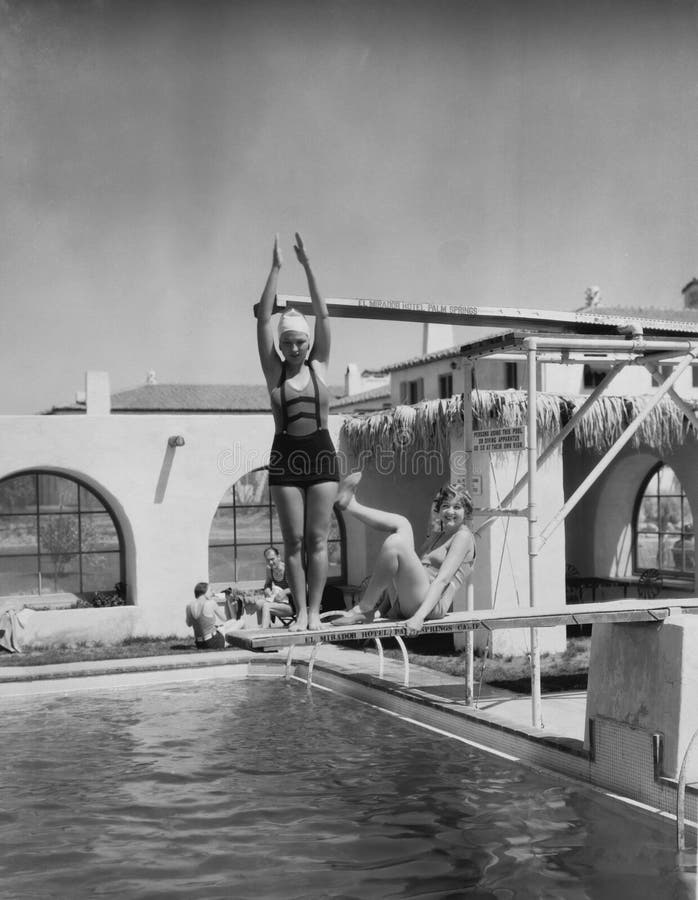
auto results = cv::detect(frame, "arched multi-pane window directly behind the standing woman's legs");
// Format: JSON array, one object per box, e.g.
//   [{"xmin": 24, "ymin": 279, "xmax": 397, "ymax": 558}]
[{"xmin": 208, "ymin": 469, "xmax": 344, "ymax": 584}]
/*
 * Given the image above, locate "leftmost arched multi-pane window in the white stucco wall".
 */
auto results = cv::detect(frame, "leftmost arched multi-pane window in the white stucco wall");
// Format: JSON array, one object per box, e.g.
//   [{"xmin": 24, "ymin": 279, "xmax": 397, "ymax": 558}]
[{"xmin": 0, "ymin": 471, "xmax": 125, "ymax": 597}]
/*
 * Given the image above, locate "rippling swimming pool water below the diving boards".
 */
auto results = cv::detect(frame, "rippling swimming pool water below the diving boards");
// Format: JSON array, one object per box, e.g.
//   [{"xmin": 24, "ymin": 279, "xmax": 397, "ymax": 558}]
[{"xmin": 0, "ymin": 679, "xmax": 695, "ymax": 900}]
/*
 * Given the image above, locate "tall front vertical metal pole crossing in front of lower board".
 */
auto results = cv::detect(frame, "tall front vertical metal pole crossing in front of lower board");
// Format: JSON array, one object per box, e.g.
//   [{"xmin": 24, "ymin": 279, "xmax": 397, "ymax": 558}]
[{"xmin": 526, "ymin": 338, "xmax": 543, "ymax": 728}]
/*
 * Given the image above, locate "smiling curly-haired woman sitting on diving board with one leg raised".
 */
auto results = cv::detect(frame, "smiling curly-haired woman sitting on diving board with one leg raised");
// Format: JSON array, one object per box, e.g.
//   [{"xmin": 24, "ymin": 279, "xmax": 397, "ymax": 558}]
[{"xmin": 332, "ymin": 472, "xmax": 475, "ymax": 635}]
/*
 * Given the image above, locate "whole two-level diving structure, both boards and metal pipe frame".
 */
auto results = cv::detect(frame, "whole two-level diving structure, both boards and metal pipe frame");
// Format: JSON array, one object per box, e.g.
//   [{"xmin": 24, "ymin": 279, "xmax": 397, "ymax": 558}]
[{"xmin": 253, "ymin": 294, "xmax": 698, "ymax": 728}]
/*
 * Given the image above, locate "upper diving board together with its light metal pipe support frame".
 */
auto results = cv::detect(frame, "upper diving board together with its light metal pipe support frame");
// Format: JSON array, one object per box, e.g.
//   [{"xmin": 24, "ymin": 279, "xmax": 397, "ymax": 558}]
[{"xmin": 256, "ymin": 295, "xmax": 698, "ymax": 728}]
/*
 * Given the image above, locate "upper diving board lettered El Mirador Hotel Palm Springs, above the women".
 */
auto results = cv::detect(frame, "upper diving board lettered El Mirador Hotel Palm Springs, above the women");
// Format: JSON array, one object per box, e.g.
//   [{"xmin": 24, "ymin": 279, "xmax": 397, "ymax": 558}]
[{"xmin": 254, "ymin": 294, "xmax": 698, "ymax": 337}]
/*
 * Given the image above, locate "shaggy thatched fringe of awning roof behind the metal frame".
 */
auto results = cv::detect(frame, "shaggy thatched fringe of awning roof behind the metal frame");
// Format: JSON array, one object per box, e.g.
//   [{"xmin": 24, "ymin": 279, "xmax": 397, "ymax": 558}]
[{"xmin": 342, "ymin": 391, "xmax": 696, "ymax": 455}]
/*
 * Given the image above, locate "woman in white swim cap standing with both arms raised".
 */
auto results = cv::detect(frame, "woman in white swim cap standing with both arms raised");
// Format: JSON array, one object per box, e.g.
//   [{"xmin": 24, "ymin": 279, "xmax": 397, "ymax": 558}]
[{"xmin": 257, "ymin": 234, "xmax": 339, "ymax": 631}]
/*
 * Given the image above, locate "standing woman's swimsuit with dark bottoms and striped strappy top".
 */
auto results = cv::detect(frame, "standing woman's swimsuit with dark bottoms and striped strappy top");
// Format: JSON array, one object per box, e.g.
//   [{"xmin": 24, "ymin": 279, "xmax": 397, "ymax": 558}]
[{"xmin": 269, "ymin": 362, "xmax": 339, "ymax": 487}]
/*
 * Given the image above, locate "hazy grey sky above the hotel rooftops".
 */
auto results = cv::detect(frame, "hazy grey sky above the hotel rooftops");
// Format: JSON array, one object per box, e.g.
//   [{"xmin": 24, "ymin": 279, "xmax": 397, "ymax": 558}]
[{"xmin": 0, "ymin": 0, "xmax": 698, "ymax": 415}]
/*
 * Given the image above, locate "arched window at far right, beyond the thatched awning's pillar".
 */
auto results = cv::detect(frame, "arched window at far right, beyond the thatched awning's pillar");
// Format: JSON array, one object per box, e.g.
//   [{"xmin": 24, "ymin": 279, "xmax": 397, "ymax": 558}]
[{"xmin": 633, "ymin": 463, "xmax": 695, "ymax": 578}]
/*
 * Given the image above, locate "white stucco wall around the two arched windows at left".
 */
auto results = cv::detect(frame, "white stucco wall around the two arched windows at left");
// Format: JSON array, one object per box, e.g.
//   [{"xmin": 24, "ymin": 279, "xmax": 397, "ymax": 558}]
[{"xmin": 0, "ymin": 415, "xmax": 342, "ymax": 637}]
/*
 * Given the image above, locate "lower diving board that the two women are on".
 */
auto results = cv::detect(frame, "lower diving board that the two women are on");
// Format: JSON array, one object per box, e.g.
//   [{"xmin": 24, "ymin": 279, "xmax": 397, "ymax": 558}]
[{"xmin": 226, "ymin": 597, "xmax": 698, "ymax": 650}]
